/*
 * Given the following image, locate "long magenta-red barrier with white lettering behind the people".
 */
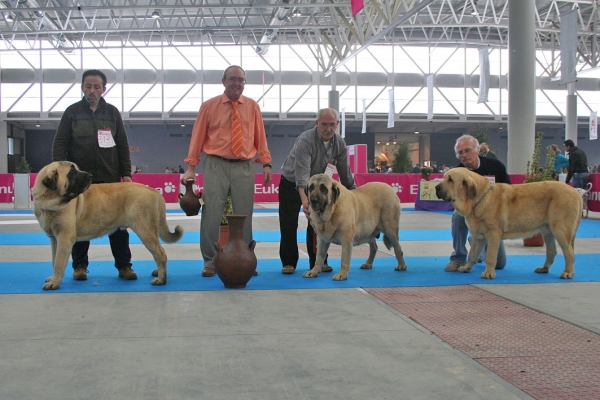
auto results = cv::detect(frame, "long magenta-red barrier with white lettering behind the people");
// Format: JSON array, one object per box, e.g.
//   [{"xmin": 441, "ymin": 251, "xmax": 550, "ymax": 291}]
[{"xmin": 0, "ymin": 174, "xmax": 600, "ymax": 211}]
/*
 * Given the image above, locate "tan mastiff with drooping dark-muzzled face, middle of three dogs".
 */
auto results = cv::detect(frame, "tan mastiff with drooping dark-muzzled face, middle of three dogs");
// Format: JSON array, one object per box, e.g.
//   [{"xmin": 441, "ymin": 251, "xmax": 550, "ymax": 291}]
[{"xmin": 304, "ymin": 174, "xmax": 406, "ymax": 281}]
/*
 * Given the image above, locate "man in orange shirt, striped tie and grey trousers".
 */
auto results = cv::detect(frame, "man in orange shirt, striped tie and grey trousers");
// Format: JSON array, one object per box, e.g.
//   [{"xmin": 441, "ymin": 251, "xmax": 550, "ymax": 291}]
[{"xmin": 181, "ymin": 65, "xmax": 271, "ymax": 276}]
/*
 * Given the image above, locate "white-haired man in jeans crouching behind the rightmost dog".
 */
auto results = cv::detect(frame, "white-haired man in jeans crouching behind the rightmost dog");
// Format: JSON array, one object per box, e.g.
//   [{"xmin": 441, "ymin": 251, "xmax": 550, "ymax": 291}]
[{"xmin": 444, "ymin": 135, "xmax": 510, "ymax": 272}]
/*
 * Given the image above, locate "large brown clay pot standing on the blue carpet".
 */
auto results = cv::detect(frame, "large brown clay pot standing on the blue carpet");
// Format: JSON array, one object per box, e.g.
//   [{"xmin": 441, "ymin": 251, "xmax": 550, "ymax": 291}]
[{"xmin": 213, "ymin": 215, "xmax": 257, "ymax": 289}]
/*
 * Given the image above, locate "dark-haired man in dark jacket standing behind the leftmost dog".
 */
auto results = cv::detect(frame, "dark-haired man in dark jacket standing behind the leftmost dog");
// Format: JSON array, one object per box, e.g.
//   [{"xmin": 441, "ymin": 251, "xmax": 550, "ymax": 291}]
[{"xmin": 52, "ymin": 70, "xmax": 137, "ymax": 280}]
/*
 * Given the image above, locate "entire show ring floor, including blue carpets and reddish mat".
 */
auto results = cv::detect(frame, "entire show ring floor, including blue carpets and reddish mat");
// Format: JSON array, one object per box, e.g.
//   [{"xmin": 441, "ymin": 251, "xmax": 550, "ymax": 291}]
[{"xmin": 0, "ymin": 204, "xmax": 600, "ymax": 400}]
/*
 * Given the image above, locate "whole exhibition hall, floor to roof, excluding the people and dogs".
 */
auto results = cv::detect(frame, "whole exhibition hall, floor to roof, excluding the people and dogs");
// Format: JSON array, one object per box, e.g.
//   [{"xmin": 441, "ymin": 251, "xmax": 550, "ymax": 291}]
[{"xmin": 0, "ymin": 0, "xmax": 600, "ymax": 400}]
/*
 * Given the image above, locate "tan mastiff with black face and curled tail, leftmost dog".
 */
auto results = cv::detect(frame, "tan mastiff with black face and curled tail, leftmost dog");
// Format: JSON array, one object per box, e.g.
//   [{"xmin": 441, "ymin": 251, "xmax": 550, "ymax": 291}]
[{"xmin": 32, "ymin": 161, "xmax": 183, "ymax": 290}]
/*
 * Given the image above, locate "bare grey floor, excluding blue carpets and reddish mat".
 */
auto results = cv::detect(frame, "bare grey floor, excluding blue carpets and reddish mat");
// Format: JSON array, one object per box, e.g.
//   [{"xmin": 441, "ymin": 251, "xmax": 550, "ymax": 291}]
[{"xmin": 0, "ymin": 204, "xmax": 600, "ymax": 400}]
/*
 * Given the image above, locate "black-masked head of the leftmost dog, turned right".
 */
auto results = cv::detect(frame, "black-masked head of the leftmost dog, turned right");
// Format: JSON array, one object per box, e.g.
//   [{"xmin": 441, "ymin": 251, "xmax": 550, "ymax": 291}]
[{"xmin": 32, "ymin": 161, "xmax": 92, "ymax": 208}]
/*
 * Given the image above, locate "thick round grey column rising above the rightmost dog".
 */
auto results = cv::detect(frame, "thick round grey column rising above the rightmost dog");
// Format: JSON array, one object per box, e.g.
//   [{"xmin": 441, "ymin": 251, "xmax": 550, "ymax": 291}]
[{"xmin": 506, "ymin": 1, "xmax": 535, "ymax": 174}]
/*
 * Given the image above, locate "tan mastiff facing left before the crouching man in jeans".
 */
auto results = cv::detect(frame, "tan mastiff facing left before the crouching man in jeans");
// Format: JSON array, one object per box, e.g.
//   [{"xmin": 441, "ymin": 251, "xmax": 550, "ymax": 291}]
[{"xmin": 435, "ymin": 168, "xmax": 582, "ymax": 279}]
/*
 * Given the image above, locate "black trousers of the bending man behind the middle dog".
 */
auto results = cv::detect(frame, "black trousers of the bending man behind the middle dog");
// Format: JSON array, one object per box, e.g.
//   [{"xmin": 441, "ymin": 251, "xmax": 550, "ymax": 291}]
[{"xmin": 279, "ymin": 176, "xmax": 327, "ymax": 269}]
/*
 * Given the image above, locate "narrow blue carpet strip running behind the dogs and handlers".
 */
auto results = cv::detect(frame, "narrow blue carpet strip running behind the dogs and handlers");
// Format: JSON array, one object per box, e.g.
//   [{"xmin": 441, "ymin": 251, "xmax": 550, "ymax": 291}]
[{"xmin": 0, "ymin": 219, "xmax": 600, "ymax": 246}]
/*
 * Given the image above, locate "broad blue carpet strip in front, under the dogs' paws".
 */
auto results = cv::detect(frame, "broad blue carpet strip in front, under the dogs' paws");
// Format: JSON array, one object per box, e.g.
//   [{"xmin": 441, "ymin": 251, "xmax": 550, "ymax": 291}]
[{"xmin": 0, "ymin": 254, "xmax": 600, "ymax": 294}]
